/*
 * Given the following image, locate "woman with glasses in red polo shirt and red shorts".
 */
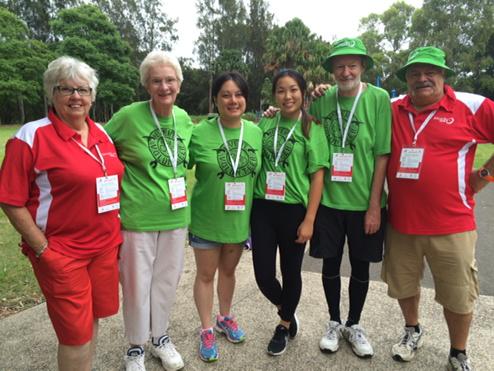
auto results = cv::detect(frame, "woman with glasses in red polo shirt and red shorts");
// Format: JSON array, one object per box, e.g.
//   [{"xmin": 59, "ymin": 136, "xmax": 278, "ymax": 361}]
[{"xmin": 0, "ymin": 57, "xmax": 123, "ymax": 370}]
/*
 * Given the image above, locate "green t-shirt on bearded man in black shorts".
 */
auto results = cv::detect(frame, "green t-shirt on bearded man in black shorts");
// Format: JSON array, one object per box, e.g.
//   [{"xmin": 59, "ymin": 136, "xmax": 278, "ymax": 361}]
[{"xmin": 310, "ymin": 84, "xmax": 391, "ymax": 211}]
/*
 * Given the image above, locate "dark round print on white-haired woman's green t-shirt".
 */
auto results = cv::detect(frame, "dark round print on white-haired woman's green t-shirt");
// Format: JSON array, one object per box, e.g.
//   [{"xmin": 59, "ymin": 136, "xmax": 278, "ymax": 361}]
[{"xmin": 144, "ymin": 128, "xmax": 186, "ymax": 169}]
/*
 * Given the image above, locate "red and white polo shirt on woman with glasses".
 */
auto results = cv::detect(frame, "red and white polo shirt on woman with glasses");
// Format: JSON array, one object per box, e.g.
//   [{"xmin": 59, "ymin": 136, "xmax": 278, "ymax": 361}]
[{"xmin": 0, "ymin": 112, "xmax": 124, "ymax": 258}]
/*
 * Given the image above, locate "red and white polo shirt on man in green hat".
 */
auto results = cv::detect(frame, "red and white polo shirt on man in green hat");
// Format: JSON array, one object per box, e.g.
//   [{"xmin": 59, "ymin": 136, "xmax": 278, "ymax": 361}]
[{"xmin": 387, "ymin": 86, "xmax": 494, "ymax": 235}]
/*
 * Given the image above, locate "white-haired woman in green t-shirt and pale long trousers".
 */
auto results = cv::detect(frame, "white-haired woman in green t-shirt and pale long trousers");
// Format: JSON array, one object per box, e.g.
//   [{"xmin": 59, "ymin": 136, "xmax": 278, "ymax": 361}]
[{"xmin": 105, "ymin": 51, "xmax": 193, "ymax": 370}]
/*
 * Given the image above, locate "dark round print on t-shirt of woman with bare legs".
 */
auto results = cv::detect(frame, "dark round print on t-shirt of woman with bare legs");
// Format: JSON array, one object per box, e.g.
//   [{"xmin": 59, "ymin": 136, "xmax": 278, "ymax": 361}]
[{"xmin": 215, "ymin": 139, "xmax": 257, "ymax": 179}]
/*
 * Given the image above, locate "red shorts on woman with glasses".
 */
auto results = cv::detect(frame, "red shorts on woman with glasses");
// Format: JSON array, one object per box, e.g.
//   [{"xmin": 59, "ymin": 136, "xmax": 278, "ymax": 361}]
[{"xmin": 28, "ymin": 248, "xmax": 119, "ymax": 345}]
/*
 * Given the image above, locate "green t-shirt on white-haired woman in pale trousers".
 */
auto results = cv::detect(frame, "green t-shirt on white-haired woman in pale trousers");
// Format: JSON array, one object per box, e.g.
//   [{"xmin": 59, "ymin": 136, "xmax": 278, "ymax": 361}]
[{"xmin": 104, "ymin": 101, "xmax": 193, "ymax": 231}]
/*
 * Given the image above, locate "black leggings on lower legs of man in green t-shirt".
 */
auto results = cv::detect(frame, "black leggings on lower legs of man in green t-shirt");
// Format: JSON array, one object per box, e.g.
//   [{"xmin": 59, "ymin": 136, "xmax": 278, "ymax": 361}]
[{"xmin": 322, "ymin": 254, "xmax": 370, "ymax": 324}]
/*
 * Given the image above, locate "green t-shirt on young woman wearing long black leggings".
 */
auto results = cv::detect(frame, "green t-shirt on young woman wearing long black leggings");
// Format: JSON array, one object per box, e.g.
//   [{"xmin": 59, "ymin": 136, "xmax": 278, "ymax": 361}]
[{"xmin": 254, "ymin": 114, "xmax": 329, "ymax": 206}]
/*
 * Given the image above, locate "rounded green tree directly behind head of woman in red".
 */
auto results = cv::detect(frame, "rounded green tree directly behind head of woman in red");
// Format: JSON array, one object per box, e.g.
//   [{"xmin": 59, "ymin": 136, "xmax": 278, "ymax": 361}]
[{"xmin": 52, "ymin": 5, "xmax": 139, "ymax": 121}]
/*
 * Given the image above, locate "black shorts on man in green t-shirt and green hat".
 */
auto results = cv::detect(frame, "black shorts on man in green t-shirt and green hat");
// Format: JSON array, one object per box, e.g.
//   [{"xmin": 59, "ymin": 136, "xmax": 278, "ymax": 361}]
[{"xmin": 309, "ymin": 205, "xmax": 387, "ymax": 262}]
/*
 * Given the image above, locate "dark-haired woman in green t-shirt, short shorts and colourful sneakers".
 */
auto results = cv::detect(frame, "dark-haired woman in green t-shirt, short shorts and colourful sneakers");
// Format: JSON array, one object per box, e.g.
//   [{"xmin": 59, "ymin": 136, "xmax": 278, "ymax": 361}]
[{"xmin": 189, "ymin": 72, "xmax": 262, "ymax": 362}]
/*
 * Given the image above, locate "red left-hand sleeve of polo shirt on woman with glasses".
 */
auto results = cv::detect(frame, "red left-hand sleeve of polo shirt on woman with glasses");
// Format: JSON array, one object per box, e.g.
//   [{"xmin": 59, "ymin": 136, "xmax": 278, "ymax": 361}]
[{"xmin": 0, "ymin": 138, "xmax": 36, "ymax": 207}]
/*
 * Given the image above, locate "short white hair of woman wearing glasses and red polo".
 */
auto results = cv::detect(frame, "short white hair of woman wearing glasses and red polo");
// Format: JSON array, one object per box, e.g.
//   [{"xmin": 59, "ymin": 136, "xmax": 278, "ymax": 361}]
[{"xmin": 43, "ymin": 55, "xmax": 99, "ymax": 104}]
